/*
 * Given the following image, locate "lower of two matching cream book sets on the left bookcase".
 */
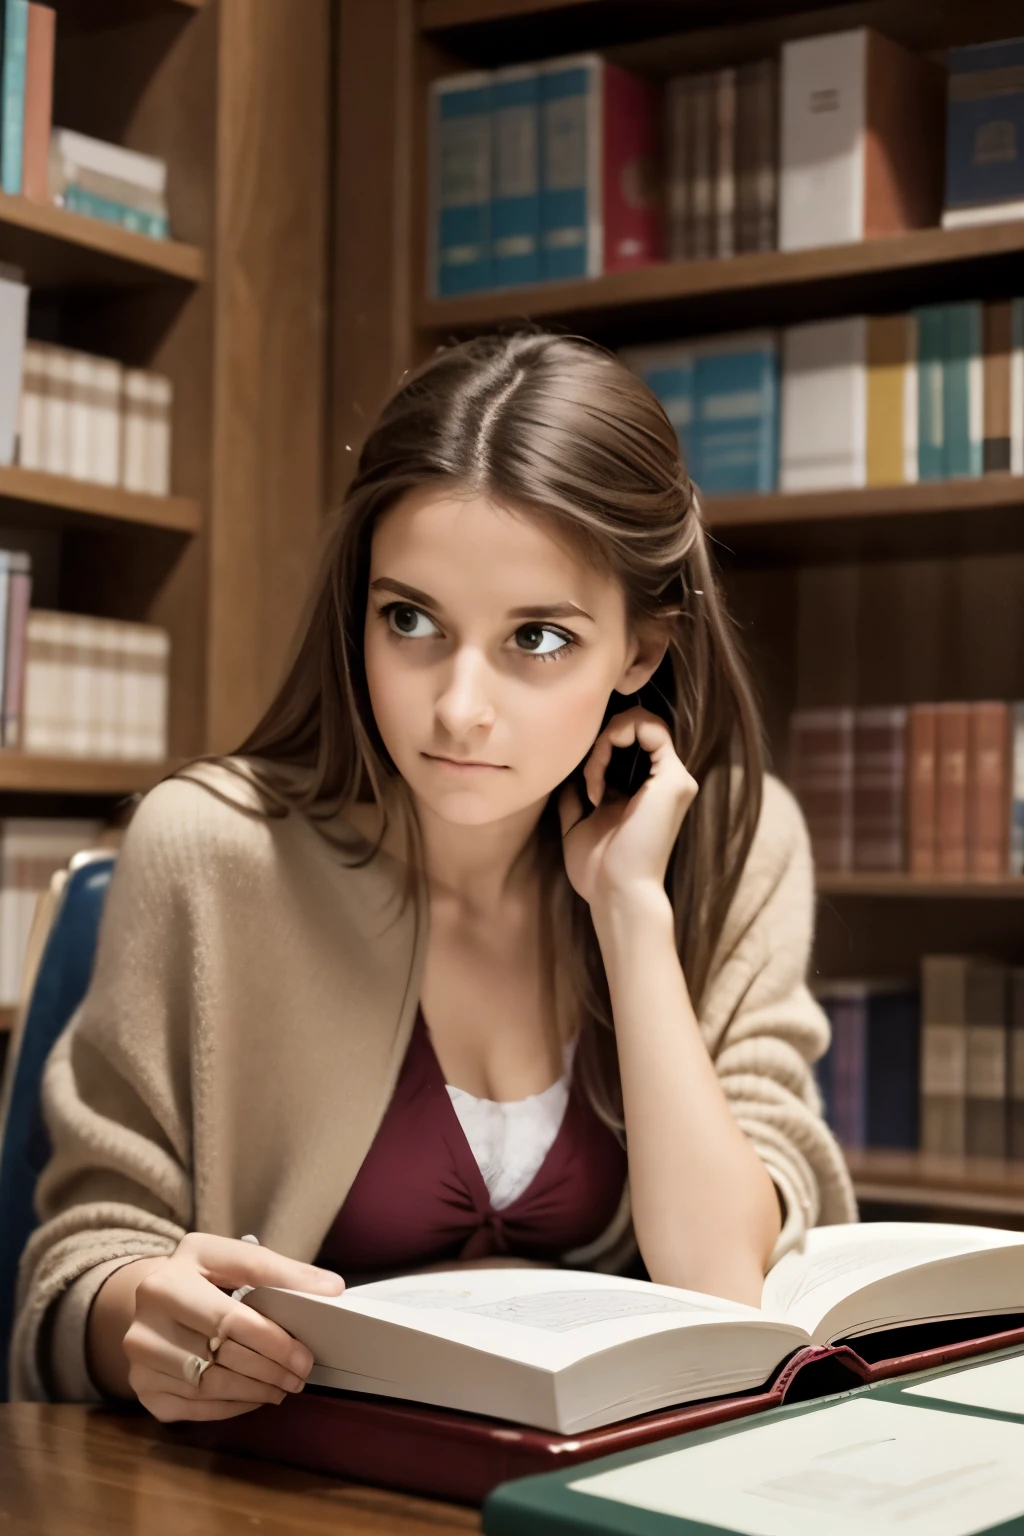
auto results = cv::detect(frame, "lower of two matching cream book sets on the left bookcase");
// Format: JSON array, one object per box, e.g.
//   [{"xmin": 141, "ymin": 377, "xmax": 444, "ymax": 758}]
[{"xmin": 21, "ymin": 608, "xmax": 170, "ymax": 762}]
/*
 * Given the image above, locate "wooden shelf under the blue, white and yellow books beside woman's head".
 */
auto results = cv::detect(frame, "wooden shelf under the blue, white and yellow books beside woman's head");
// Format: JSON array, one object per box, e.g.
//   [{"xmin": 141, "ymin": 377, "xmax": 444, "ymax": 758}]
[{"xmin": 703, "ymin": 475, "xmax": 1024, "ymax": 564}]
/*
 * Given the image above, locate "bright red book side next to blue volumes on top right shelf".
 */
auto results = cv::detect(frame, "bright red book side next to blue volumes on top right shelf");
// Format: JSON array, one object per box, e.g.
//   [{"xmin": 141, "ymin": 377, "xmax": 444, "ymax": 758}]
[{"xmin": 602, "ymin": 63, "xmax": 663, "ymax": 272}]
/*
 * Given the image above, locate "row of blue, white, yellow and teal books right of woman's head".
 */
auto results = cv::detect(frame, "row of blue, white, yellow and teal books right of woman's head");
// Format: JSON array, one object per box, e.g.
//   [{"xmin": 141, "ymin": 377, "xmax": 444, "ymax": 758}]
[{"xmin": 620, "ymin": 300, "xmax": 1024, "ymax": 496}]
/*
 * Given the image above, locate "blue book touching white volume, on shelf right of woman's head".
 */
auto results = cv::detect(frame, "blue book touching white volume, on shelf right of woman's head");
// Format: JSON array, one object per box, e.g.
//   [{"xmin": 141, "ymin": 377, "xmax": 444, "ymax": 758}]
[{"xmin": 691, "ymin": 332, "xmax": 778, "ymax": 496}]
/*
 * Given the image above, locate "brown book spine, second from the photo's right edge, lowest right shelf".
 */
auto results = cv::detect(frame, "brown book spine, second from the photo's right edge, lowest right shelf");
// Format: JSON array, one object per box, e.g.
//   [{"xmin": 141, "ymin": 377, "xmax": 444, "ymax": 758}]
[{"xmin": 964, "ymin": 962, "xmax": 1009, "ymax": 1158}]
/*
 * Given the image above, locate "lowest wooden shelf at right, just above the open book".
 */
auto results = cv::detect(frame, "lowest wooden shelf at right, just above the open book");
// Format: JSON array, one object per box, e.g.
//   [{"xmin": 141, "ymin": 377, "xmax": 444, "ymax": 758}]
[{"xmin": 843, "ymin": 1147, "xmax": 1024, "ymax": 1217}]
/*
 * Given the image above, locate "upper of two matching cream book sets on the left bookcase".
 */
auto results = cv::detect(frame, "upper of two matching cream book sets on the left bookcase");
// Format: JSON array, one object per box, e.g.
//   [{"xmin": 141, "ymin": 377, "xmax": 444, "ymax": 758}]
[{"xmin": 17, "ymin": 341, "xmax": 173, "ymax": 496}]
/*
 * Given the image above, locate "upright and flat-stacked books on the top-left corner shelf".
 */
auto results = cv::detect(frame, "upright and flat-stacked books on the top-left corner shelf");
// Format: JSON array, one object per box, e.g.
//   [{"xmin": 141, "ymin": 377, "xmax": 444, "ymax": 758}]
[{"xmin": 0, "ymin": 0, "xmax": 169, "ymax": 240}]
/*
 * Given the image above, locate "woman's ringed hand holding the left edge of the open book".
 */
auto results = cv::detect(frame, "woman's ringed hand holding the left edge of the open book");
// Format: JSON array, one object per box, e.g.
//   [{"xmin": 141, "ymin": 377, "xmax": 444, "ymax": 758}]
[{"xmin": 122, "ymin": 1232, "xmax": 345, "ymax": 1422}]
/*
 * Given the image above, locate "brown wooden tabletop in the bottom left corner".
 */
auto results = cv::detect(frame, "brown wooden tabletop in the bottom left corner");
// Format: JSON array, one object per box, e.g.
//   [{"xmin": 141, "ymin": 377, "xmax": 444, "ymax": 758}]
[{"xmin": 0, "ymin": 1402, "xmax": 481, "ymax": 1536}]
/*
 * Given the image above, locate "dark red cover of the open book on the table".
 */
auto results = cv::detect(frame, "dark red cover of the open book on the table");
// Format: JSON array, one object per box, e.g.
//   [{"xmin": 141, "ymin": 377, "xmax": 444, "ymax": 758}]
[{"xmin": 176, "ymin": 1316, "xmax": 1024, "ymax": 1504}]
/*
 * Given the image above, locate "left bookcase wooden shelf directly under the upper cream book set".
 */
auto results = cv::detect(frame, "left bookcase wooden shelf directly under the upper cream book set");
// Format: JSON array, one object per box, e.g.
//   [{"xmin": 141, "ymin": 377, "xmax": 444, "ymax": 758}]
[{"xmin": 0, "ymin": 464, "xmax": 203, "ymax": 535}]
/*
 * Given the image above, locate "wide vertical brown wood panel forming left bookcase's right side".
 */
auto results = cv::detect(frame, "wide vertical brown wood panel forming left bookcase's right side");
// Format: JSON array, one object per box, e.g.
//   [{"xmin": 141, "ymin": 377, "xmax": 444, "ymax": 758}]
[{"xmin": 206, "ymin": 0, "xmax": 330, "ymax": 751}]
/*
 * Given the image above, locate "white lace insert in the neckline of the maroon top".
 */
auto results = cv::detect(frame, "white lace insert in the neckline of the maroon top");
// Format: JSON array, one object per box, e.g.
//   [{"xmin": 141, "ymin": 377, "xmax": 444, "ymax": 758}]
[{"xmin": 445, "ymin": 1040, "xmax": 576, "ymax": 1210}]
